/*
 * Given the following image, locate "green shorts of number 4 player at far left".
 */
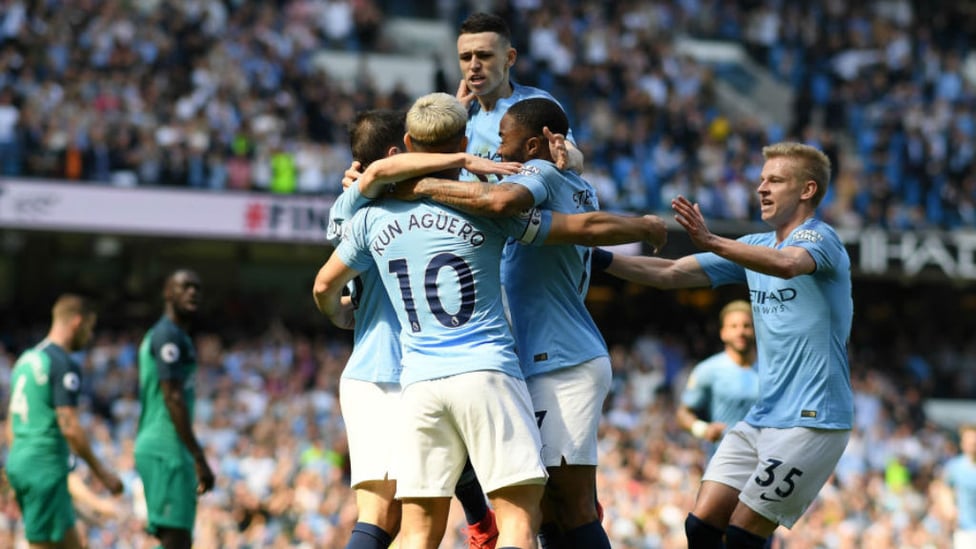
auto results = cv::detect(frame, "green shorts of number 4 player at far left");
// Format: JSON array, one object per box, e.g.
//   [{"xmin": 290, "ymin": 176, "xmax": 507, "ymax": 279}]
[{"xmin": 7, "ymin": 464, "xmax": 75, "ymax": 543}]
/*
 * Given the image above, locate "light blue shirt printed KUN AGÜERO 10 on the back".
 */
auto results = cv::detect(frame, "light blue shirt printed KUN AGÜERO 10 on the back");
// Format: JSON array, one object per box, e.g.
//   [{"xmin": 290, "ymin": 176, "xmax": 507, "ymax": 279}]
[{"xmin": 336, "ymin": 200, "xmax": 552, "ymax": 387}]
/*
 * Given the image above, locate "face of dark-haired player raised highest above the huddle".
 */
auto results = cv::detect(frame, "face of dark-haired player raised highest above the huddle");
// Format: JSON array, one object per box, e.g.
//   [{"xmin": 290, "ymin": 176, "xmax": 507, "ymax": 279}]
[{"xmin": 458, "ymin": 32, "xmax": 515, "ymax": 98}]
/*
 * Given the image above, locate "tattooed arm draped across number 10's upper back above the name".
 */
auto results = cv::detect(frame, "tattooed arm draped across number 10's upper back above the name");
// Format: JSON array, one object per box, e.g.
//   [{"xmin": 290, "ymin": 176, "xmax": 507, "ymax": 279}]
[{"xmin": 412, "ymin": 177, "xmax": 535, "ymax": 217}]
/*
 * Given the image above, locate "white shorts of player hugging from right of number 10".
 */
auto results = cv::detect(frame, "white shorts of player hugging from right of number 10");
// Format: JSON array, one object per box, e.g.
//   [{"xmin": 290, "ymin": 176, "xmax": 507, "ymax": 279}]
[{"xmin": 526, "ymin": 357, "xmax": 612, "ymax": 467}]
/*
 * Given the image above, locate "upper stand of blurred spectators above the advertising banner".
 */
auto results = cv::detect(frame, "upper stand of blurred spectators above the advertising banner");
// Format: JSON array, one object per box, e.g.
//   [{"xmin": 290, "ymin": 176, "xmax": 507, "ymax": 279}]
[{"xmin": 0, "ymin": 0, "xmax": 976, "ymax": 229}]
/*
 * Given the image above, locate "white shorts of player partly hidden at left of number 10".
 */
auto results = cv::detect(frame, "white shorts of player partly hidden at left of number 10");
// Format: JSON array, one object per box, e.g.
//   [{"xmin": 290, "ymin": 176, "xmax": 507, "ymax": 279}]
[{"xmin": 339, "ymin": 379, "xmax": 400, "ymax": 488}]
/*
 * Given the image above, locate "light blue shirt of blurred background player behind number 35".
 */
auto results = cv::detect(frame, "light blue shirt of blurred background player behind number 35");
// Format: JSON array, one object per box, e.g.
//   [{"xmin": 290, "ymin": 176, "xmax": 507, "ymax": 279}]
[{"xmin": 681, "ymin": 351, "xmax": 759, "ymax": 427}]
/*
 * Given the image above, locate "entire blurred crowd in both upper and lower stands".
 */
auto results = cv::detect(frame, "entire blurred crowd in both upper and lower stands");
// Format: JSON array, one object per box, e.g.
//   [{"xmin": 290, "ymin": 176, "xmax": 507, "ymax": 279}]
[{"xmin": 0, "ymin": 0, "xmax": 976, "ymax": 549}]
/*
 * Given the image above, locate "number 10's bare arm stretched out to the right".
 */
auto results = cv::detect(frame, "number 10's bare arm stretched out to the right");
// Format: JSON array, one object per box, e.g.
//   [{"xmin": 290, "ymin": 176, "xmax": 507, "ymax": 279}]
[{"xmin": 545, "ymin": 212, "xmax": 668, "ymax": 253}]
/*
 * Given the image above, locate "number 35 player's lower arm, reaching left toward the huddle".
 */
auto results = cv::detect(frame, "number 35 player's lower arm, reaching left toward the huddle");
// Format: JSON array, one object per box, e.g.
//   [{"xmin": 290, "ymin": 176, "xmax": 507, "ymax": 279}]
[{"xmin": 606, "ymin": 254, "xmax": 711, "ymax": 290}]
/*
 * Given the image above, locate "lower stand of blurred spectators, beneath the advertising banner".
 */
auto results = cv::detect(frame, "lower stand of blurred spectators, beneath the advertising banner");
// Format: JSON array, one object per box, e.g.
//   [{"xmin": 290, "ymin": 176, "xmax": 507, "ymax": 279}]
[{"xmin": 0, "ymin": 286, "xmax": 976, "ymax": 549}]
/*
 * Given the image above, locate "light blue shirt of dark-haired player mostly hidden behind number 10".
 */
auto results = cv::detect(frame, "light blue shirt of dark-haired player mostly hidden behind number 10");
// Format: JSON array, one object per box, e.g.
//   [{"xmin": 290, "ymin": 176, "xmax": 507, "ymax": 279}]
[{"xmin": 326, "ymin": 185, "xmax": 401, "ymax": 383}]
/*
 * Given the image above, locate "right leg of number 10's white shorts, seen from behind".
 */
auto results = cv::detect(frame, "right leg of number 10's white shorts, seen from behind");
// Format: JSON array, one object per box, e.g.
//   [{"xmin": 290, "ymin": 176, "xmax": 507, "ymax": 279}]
[{"xmin": 451, "ymin": 371, "xmax": 546, "ymax": 493}]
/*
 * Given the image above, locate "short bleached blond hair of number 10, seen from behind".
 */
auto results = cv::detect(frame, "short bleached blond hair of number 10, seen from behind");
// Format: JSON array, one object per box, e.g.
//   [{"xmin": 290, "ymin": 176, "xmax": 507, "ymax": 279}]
[{"xmin": 407, "ymin": 92, "xmax": 468, "ymax": 148}]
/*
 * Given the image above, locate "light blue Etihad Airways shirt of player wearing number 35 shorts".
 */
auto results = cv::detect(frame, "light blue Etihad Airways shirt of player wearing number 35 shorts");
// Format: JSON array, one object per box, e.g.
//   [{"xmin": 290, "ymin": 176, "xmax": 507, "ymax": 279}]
[{"xmin": 695, "ymin": 218, "xmax": 854, "ymax": 429}]
